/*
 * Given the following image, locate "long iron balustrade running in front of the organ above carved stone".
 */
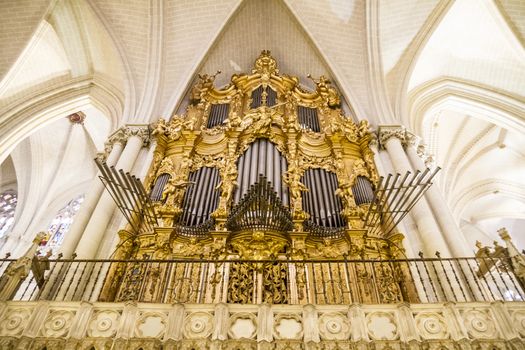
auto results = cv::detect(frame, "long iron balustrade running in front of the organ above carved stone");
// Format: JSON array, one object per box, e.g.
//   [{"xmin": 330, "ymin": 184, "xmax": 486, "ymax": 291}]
[{"xmin": 0, "ymin": 257, "xmax": 525, "ymax": 304}]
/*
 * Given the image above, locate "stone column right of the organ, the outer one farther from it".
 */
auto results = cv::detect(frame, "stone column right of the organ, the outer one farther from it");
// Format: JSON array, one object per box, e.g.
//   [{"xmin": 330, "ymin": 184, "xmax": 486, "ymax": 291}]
[{"xmin": 406, "ymin": 133, "xmax": 472, "ymax": 257}]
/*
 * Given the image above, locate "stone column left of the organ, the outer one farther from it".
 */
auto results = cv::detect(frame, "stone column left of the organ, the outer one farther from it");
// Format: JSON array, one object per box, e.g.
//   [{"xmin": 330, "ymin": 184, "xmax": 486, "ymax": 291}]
[{"xmin": 58, "ymin": 135, "xmax": 125, "ymax": 259}]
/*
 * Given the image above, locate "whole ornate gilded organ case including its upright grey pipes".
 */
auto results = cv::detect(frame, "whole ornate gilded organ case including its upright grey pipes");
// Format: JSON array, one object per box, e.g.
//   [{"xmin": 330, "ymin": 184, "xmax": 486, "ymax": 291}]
[{"xmin": 101, "ymin": 51, "xmax": 414, "ymax": 303}]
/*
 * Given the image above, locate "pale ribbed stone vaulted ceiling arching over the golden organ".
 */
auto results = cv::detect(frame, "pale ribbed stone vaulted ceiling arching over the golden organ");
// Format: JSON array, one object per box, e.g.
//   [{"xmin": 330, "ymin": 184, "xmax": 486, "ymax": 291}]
[{"xmin": 0, "ymin": 0, "xmax": 525, "ymax": 250}]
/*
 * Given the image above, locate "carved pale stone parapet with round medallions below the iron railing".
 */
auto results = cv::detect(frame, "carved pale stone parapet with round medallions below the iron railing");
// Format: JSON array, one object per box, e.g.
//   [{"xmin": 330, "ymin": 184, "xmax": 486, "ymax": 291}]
[{"xmin": 0, "ymin": 301, "xmax": 525, "ymax": 350}]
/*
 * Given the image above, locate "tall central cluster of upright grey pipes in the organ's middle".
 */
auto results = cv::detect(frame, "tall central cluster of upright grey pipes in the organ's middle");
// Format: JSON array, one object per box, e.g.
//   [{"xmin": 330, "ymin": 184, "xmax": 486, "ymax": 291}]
[{"xmin": 234, "ymin": 139, "xmax": 289, "ymax": 205}]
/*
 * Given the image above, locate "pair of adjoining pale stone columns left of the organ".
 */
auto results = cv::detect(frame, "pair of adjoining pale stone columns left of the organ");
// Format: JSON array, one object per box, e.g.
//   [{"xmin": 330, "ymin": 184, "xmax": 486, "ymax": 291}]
[{"xmin": 60, "ymin": 125, "xmax": 149, "ymax": 259}]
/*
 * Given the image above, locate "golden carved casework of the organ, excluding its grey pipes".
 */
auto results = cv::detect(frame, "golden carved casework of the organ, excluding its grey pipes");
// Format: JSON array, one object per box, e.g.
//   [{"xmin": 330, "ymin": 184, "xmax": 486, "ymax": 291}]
[{"xmin": 103, "ymin": 51, "xmax": 406, "ymax": 303}]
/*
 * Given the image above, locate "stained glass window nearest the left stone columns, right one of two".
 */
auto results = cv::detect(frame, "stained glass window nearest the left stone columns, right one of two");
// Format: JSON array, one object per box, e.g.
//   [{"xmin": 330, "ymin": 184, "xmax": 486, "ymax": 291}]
[{"xmin": 40, "ymin": 194, "xmax": 84, "ymax": 258}]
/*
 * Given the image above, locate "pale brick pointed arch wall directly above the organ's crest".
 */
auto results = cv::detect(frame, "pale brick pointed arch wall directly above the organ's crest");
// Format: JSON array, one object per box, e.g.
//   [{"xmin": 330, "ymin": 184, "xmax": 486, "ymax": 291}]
[{"xmin": 161, "ymin": 0, "xmax": 357, "ymax": 119}]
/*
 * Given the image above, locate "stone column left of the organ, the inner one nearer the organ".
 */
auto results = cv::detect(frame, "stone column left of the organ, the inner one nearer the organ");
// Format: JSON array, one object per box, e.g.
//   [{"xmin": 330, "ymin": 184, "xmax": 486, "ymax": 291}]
[{"xmin": 73, "ymin": 127, "xmax": 148, "ymax": 259}]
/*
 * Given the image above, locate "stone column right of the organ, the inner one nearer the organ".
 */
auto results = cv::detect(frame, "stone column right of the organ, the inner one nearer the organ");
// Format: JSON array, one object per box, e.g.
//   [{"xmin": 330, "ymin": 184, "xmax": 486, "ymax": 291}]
[{"xmin": 379, "ymin": 126, "xmax": 450, "ymax": 257}]
